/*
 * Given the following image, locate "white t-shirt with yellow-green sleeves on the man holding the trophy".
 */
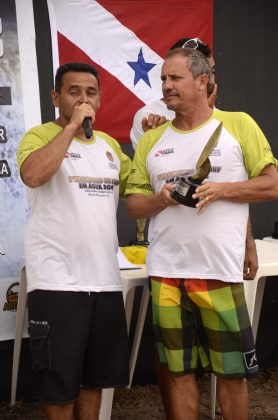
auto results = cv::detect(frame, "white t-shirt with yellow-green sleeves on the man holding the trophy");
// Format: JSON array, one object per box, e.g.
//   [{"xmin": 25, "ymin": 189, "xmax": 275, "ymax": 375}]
[{"xmin": 126, "ymin": 110, "xmax": 276, "ymax": 282}]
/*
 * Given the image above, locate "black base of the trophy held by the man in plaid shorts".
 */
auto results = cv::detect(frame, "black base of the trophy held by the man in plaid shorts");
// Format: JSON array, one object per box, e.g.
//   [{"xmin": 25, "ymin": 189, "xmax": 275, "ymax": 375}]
[{"xmin": 171, "ymin": 176, "xmax": 202, "ymax": 207}]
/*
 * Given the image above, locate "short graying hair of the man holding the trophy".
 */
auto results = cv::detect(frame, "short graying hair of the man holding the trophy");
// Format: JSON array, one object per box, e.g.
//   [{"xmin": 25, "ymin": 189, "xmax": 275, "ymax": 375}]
[{"xmin": 166, "ymin": 48, "xmax": 211, "ymax": 81}]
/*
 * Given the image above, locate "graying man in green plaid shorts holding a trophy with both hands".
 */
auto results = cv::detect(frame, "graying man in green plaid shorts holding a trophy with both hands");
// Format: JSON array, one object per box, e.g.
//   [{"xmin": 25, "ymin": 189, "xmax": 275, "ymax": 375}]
[{"xmin": 126, "ymin": 48, "xmax": 278, "ymax": 420}]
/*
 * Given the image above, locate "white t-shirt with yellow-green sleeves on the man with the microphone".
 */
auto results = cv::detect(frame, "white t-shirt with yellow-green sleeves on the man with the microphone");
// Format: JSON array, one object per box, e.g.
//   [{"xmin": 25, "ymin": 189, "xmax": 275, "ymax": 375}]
[{"xmin": 18, "ymin": 122, "xmax": 131, "ymax": 292}]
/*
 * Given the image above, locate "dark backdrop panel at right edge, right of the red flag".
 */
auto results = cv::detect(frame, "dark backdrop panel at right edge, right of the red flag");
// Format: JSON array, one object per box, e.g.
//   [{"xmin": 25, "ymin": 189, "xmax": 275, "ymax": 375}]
[{"xmin": 214, "ymin": 0, "xmax": 278, "ymax": 238}]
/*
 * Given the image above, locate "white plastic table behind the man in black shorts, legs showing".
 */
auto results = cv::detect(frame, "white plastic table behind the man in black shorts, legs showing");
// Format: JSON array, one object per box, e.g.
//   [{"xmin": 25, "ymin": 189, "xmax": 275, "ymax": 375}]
[{"xmin": 11, "ymin": 267, "xmax": 150, "ymax": 420}]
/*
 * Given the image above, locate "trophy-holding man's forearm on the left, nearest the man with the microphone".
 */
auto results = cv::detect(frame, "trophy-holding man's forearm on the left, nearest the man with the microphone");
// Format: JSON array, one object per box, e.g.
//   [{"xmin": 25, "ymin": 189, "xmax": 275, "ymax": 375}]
[{"xmin": 126, "ymin": 193, "xmax": 169, "ymax": 219}]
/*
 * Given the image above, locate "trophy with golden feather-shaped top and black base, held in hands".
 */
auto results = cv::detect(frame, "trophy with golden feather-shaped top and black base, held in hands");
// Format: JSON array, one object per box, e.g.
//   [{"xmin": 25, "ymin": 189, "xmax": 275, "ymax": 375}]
[{"xmin": 171, "ymin": 122, "xmax": 222, "ymax": 207}]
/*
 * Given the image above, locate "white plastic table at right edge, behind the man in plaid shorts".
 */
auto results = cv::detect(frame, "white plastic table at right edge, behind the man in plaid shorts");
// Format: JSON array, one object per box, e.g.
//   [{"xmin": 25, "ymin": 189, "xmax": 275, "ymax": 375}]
[{"xmin": 211, "ymin": 239, "xmax": 278, "ymax": 419}]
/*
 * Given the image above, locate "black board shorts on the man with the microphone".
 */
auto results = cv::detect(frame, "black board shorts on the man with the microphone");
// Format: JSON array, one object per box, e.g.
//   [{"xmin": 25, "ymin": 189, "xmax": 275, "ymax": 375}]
[{"xmin": 28, "ymin": 290, "xmax": 129, "ymax": 404}]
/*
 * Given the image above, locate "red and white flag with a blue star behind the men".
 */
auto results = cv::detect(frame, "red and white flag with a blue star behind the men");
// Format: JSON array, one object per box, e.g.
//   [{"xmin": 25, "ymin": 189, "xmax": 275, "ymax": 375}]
[{"xmin": 48, "ymin": 0, "xmax": 213, "ymax": 142}]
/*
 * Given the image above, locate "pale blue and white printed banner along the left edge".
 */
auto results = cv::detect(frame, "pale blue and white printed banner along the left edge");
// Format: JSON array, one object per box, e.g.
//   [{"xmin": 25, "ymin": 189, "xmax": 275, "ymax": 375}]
[{"xmin": 0, "ymin": 0, "xmax": 40, "ymax": 340}]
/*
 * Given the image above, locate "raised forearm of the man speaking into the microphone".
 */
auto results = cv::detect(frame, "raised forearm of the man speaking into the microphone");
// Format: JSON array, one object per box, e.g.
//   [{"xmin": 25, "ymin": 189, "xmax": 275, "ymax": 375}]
[{"xmin": 20, "ymin": 125, "xmax": 76, "ymax": 188}]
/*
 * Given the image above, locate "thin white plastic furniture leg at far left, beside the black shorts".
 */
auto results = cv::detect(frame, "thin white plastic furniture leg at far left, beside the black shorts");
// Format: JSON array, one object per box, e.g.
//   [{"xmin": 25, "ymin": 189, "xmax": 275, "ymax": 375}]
[{"xmin": 11, "ymin": 267, "xmax": 27, "ymax": 405}]
